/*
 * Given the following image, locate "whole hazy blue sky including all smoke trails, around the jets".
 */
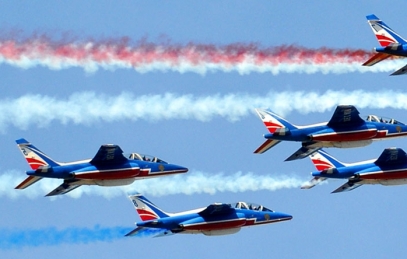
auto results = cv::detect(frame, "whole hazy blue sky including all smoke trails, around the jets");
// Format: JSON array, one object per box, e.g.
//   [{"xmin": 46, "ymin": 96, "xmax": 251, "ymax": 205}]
[{"xmin": 0, "ymin": 0, "xmax": 407, "ymax": 259}]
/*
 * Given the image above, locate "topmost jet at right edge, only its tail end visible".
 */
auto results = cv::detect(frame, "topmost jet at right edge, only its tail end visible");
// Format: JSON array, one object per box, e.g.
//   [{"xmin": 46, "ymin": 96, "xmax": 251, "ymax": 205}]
[{"xmin": 363, "ymin": 14, "xmax": 407, "ymax": 75}]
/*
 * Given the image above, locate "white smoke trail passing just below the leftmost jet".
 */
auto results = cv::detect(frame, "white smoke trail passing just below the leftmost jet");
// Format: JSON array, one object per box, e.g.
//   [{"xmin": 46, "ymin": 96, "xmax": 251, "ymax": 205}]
[{"xmin": 0, "ymin": 171, "xmax": 306, "ymax": 199}]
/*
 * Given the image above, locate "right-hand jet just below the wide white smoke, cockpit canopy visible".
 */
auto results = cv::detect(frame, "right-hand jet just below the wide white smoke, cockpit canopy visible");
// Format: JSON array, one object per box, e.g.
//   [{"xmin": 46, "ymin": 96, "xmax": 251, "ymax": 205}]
[{"xmin": 254, "ymin": 105, "xmax": 407, "ymax": 161}]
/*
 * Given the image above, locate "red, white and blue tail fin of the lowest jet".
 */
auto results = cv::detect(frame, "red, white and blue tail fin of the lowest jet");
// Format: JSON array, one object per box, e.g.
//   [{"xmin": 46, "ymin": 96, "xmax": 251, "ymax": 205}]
[{"xmin": 129, "ymin": 194, "xmax": 170, "ymax": 221}]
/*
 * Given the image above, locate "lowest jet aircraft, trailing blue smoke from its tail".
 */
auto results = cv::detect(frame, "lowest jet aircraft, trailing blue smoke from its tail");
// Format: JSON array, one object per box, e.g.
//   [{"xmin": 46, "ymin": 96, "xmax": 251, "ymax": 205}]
[{"xmin": 126, "ymin": 194, "xmax": 292, "ymax": 237}]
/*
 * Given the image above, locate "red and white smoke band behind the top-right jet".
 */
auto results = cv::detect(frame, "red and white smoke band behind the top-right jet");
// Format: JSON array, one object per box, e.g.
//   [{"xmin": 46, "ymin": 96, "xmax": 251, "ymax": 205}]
[{"xmin": 0, "ymin": 35, "xmax": 402, "ymax": 74}]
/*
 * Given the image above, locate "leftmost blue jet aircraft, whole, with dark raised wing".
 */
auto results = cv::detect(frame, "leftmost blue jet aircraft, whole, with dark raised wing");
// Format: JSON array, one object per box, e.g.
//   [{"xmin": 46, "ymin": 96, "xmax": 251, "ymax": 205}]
[{"xmin": 16, "ymin": 139, "xmax": 188, "ymax": 196}]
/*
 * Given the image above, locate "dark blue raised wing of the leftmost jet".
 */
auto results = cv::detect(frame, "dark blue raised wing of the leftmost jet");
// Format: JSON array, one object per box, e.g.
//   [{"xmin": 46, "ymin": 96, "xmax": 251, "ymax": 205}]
[{"xmin": 90, "ymin": 145, "xmax": 127, "ymax": 165}]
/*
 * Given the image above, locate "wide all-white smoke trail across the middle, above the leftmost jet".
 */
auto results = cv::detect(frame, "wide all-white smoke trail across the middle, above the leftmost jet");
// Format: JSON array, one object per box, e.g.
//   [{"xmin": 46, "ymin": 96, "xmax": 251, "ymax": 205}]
[{"xmin": 0, "ymin": 90, "xmax": 407, "ymax": 133}]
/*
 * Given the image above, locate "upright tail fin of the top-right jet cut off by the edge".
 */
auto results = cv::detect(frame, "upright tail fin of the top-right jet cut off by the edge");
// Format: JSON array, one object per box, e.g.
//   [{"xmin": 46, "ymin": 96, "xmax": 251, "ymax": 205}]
[{"xmin": 366, "ymin": 14, "xmax": 407, "ymax": 47}]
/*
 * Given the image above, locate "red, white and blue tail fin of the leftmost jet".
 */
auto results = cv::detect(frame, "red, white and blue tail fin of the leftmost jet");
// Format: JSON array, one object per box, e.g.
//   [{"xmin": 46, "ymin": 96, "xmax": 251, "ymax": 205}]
[{"xmin": 16, "ymin": 138, "xmax": 60, "ymax": 170}]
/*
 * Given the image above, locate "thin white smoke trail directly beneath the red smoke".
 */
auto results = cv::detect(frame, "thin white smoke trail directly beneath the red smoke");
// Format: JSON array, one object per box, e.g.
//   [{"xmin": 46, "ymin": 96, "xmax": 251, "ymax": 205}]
[{"xmin": 0, "ymin": 56, "xmax": 406, "ymax": 75}]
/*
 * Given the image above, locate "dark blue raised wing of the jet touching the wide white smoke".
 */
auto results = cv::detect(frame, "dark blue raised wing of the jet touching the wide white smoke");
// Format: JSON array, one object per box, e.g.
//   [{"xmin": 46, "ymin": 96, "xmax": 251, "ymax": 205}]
[{"xmin": 327, "ymin": 105, "xmax": 365, "ymax": 127}]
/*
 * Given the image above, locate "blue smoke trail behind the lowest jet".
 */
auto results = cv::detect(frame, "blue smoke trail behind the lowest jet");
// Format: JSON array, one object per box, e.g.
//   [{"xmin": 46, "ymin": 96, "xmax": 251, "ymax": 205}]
[{"xmin": 0, "ymin": 225, "xmax": 131, "ymax": 250}]
